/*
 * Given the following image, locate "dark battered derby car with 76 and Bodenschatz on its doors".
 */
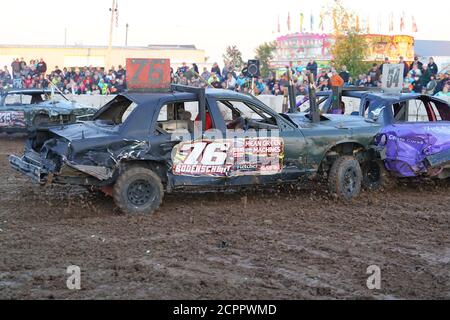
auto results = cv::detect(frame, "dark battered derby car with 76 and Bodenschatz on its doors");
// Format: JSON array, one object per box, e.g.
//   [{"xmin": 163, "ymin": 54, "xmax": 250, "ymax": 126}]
[{"xmin": 10, "ymin": 85, "xmax": 390, "ymax": 214}]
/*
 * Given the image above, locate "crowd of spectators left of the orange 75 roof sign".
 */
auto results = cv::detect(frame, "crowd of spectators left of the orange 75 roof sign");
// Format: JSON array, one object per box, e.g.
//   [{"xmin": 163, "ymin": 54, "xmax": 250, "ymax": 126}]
[{"xmin": 0, "ymin": 58, "xmax": 126, "ymax": 95}]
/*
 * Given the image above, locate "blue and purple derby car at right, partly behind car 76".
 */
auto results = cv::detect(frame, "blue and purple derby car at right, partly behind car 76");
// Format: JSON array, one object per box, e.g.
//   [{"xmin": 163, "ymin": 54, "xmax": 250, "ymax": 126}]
[{"xmin": 299, "ymin": 88, "xmax": 450, "ymax": 179}]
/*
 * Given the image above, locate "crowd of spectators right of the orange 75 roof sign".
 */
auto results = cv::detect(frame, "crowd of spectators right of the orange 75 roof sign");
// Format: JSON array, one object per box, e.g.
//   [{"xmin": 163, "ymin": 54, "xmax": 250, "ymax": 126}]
[{"xmin": 172, "ymin": 57, "xmax": 450, "ymax": 96}]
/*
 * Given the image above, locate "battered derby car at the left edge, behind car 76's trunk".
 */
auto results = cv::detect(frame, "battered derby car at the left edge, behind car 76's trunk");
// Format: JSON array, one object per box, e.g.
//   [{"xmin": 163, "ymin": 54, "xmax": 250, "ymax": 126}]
[{"xmin": 0, "ymin": 89, "xmax": 97, "ymax": 133}]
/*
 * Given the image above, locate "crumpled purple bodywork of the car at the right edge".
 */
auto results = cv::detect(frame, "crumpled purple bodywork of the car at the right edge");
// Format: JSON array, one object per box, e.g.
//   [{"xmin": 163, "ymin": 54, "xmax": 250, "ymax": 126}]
[{"xmin": 377, "ymin": 121, "xmax": 450, "ymax": 177}]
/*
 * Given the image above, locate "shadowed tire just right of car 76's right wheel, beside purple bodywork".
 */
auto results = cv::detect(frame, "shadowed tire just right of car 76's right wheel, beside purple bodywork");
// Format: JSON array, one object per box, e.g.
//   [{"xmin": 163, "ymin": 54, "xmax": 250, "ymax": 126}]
[{"xmin": 361, "ymin": 161, "xmax": 397, "ymax": 191}]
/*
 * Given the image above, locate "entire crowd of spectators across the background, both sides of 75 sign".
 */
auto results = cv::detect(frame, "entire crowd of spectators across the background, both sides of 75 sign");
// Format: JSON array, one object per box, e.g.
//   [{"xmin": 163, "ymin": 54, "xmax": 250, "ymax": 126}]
[{"xmin": 0, "ymin": 57, "xmax": 450, "ymax": 96}]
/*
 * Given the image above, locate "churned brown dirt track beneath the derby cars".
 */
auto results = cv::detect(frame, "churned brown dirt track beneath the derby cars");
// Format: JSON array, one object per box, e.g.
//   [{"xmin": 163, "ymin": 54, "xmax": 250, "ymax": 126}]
[{"xmin": 0, "ymin": 137, "xmax": 450, "ymax": 299}]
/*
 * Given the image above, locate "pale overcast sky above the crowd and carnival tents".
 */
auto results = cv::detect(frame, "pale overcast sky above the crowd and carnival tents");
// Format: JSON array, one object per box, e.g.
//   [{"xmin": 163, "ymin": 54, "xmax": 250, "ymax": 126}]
[{"xmin": 0, "ymin": 0, "xmax": 450, "ymax": 62}]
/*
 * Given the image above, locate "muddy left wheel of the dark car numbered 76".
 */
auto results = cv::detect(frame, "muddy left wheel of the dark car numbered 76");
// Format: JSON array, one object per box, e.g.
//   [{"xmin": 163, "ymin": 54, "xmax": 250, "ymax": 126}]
[{"xmin": 113, "ymin": 166, "xmax": 164, "ymax": 215}]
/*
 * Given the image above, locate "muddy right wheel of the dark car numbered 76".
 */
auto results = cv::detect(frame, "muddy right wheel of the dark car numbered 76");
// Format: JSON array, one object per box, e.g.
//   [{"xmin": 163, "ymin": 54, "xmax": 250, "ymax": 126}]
[{"xmin": 328, "ymin": 156, "xmax": 363, "ymax": 201}]
